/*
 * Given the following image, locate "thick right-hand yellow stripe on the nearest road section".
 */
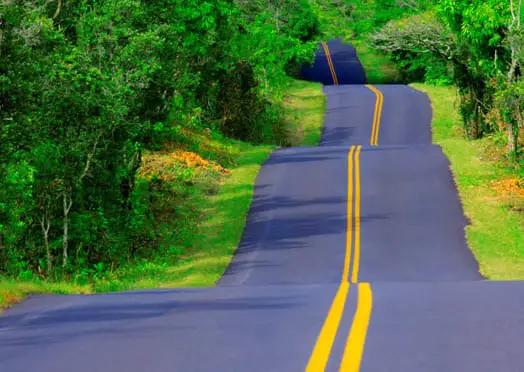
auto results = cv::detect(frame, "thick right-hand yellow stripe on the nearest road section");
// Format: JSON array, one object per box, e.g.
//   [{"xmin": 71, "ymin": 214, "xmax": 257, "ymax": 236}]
[{"xmin": 340, "ymin": 283, "xmax": 373, "ymax": 372}]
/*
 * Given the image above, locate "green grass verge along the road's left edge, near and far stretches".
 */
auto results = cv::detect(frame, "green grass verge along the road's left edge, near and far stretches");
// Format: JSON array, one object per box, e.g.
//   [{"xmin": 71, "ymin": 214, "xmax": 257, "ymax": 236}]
[{"xmin": 0, "ymin": 81, "xmax": 326, "ymax": 310}]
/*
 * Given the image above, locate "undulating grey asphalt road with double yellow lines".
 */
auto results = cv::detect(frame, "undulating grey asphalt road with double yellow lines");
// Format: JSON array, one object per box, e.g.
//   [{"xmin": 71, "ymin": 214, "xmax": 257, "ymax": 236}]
[{"xmin": 0, "ymin": 41, "xmax": 524, "ymax": 372}]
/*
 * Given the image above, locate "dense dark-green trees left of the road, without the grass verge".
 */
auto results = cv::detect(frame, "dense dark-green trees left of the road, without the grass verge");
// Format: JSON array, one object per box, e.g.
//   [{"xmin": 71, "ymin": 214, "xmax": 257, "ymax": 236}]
[{"xmin": 0, "ymin": 0, "xmax": 316, "ymax": 276}]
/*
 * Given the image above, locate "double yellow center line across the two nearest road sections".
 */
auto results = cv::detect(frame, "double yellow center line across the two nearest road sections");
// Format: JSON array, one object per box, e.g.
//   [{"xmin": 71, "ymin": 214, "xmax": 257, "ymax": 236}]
[{"xmin": 306, "ymin": 146, "xmax": 373, "ymax": 372}]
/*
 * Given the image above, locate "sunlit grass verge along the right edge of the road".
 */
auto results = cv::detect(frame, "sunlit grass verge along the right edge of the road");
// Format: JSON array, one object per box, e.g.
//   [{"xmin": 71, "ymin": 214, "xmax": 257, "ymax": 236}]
[{"xmin": 413, "ymin": 84, "xmax": 524, "ymax": 280}]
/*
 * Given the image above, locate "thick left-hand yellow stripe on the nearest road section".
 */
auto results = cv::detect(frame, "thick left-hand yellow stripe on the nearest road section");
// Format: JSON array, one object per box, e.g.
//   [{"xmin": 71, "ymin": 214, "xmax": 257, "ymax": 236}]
[{"xmin": 306, "ymin": 282, "xmax": 349, "ymax": 372}]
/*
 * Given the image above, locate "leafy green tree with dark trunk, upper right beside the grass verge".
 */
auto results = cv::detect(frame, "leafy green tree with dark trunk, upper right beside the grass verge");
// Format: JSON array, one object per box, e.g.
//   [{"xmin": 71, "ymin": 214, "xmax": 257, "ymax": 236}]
[{"xmin": 437, "ymin": 0, "xmax": 510, "ymax": 138}]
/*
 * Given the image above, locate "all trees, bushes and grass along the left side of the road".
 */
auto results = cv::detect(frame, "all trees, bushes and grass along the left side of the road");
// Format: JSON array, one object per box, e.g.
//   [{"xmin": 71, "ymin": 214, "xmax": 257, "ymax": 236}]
[{"xmin": 0, "ymin": 0, "xmax": 324, "ymax": 307}]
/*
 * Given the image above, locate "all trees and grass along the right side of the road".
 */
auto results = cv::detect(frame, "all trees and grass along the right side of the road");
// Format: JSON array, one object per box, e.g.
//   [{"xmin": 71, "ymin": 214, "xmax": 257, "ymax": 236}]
[{"xmin": 315, "ymin": 0, "xmax": 524, "ymax": 280}]
